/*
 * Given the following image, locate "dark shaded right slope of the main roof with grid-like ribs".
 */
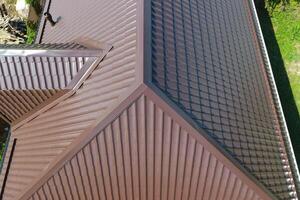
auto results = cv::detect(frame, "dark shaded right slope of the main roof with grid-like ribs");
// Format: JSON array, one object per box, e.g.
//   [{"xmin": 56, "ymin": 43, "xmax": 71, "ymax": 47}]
[{"xmin": 151, "ymin": 0, "xmax": 295, "ymax": 199}]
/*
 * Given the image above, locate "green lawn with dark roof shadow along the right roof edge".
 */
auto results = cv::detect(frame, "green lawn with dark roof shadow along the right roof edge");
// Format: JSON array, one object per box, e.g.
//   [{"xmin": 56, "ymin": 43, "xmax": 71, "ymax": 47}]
[{"xmin": 258, "ymin": 0, "xmax": 300, "ymax": 166}]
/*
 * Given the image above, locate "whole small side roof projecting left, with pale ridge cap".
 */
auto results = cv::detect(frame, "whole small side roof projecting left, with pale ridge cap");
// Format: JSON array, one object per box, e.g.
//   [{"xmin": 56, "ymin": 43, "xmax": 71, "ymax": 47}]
[{"xmin": 0, "ymin": 43, "xmax": 103, "ymax": 122}]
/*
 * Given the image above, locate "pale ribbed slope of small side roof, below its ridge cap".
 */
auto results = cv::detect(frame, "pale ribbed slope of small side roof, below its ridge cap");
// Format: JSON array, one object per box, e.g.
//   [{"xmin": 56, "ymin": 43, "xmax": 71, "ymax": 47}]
[{"xmin": 0, "ymin": 49, "xmax": 86, "ymax": 90}]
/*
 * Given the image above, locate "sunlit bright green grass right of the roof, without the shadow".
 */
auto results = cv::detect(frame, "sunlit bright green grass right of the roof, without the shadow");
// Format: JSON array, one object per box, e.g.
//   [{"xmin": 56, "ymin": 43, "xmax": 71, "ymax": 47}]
[{"xmin": 271, "ymin": 1, "xmax": 300, "ymax": 111}]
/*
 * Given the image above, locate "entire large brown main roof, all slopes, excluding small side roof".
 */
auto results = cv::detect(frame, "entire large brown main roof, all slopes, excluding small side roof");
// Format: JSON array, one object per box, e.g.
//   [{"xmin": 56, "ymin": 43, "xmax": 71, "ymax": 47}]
[{"xmin": 0, "ymin": 0, "xmax": 300, "ymax": 200}]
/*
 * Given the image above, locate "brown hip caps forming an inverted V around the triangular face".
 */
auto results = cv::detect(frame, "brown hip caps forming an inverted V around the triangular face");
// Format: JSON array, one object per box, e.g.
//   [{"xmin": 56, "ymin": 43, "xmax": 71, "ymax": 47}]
[{"xmin": 16, "ymin": 84, "xmax": 276, "ymax": 200}]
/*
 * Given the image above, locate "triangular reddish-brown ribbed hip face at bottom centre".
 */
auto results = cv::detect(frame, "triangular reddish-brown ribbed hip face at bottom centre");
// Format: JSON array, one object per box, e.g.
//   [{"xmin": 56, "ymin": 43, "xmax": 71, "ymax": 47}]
[{"xmin": 24, "ymin": 96, "xmax": 270, "ymax": 200}]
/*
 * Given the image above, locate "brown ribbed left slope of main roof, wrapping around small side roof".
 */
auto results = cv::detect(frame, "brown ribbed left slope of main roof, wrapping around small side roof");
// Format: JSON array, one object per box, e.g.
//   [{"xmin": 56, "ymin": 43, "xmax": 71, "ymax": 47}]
[{"xmin": 0, "ymin": 0, "xmax": 139, "ymax": 200}]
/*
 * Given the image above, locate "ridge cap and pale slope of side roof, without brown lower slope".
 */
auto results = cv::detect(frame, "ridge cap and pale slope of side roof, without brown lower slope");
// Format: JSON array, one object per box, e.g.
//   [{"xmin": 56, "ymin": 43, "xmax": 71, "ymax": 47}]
[{"xmin": 0, "ymin": 43, "xmax": 95, "ymax": 90}]
